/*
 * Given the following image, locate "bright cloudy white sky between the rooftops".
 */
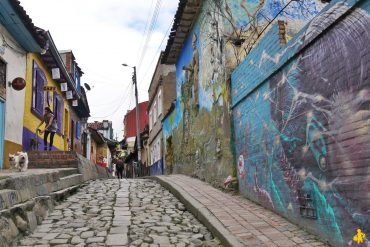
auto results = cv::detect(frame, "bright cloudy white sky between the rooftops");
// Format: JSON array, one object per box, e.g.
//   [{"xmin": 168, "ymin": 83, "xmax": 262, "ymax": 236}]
[{"xmin": 20, "ymin": 0, "xmax": 179, "ymax": 140}]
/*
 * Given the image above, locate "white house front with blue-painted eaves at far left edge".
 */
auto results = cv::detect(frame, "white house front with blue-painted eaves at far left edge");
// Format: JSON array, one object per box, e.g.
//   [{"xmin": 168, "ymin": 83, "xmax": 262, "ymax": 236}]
[{"xmin": 0, "ymin": 1, "xmax": 42, "ymax": 169}]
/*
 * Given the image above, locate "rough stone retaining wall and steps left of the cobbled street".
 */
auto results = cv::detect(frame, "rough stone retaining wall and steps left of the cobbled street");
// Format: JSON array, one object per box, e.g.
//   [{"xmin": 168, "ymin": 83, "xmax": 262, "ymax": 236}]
[{"xmin": 0, "ymin": 152, "xmax": 110, "ymax": 247}]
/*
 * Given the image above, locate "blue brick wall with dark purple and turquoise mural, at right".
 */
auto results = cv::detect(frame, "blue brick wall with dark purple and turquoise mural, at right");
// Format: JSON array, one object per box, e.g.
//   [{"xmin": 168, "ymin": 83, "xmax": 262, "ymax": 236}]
[{"xmin": 232, "ymin": 1, "xmax": 370, "ymax": 246}]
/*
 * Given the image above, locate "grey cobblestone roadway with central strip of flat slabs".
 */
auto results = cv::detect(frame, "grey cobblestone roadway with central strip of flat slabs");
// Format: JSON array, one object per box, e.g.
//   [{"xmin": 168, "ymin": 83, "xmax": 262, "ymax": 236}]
[{"xmin": 18, "ymin": 180, "xmax": 221, "ymax": 247}]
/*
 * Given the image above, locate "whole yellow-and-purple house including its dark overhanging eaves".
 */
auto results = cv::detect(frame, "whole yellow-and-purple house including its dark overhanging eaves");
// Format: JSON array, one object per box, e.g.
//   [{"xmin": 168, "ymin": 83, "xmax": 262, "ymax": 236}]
[{"xmin": 22, "ymin": 31, "xmax": 90, "ymax": 154}]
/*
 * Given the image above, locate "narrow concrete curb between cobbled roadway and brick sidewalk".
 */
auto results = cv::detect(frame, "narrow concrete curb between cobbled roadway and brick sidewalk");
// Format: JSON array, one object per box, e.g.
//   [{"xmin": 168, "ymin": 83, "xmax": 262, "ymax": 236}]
[{"xmin": 149, "ymin": 176, "xmax": 244, "ymax": 247}]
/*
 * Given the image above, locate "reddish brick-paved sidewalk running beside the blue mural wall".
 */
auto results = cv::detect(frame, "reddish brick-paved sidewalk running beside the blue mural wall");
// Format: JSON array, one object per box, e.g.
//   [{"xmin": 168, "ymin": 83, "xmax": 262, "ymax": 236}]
[{"xmin": 159, "ymin": 175, "xmax": 328, "ymax": 247}]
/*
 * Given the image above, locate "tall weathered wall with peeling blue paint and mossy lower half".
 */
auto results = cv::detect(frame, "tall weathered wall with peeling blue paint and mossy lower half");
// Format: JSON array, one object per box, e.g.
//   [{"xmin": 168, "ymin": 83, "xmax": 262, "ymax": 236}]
[{"xmin": 163, "ymin": 0, "xmax": 321, "ymax": 185}]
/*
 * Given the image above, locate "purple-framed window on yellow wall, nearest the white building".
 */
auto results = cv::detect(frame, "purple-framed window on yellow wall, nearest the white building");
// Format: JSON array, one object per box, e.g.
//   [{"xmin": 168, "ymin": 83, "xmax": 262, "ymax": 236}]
[{"xmin": 32, "ymin": 61, "xmax": 46, "ymax": 116}]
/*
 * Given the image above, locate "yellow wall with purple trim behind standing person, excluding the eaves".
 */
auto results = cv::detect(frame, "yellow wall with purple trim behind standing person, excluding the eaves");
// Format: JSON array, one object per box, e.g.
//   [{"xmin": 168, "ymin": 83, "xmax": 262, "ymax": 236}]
[{"xmin": 23, "ymin": 53, "xmax": 70, "ymax": 150}]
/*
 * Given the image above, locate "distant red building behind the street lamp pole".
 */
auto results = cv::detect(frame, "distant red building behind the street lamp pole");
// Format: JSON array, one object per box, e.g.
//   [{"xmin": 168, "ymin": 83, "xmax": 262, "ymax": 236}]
[{"xmin": 123, "ymin": 101, "xmax": 149, "ymax": 139}]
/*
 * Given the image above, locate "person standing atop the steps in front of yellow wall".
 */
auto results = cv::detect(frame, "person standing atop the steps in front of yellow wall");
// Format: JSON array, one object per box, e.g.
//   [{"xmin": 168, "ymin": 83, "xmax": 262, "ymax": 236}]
[{"xmin": 36, "ymin": 107, "xmax": 58, "ymax": 151}]
